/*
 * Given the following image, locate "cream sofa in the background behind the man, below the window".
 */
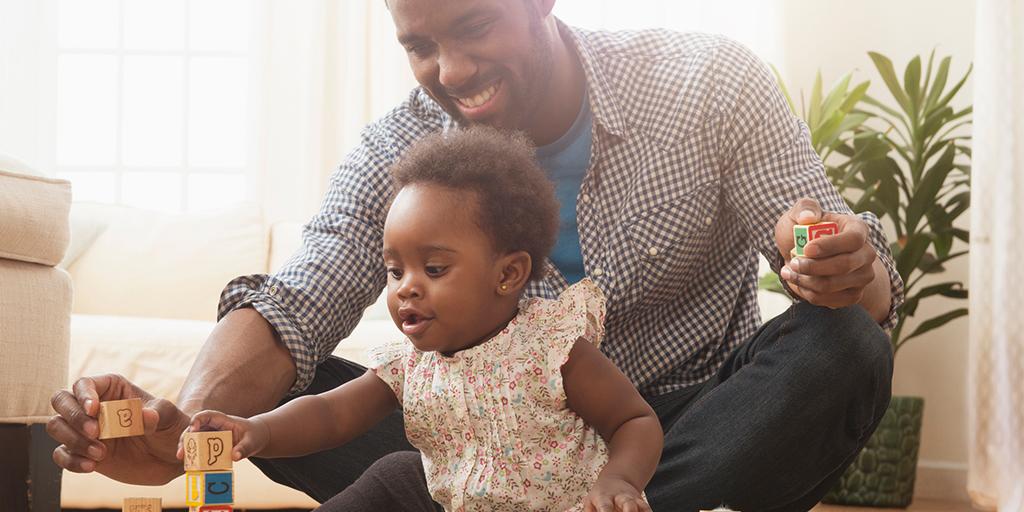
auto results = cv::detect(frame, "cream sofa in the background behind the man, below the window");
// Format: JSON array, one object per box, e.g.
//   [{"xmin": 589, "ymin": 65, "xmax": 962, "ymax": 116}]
[{"xmin": 61, "ymin": 199, "xmax": 785, "ymax": 508}]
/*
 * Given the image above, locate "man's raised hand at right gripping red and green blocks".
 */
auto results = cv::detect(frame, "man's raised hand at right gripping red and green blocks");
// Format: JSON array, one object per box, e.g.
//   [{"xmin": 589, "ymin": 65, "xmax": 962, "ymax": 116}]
[{"xmin": 775, "ymin": 198, "xmax": 889, "ymax": 307}]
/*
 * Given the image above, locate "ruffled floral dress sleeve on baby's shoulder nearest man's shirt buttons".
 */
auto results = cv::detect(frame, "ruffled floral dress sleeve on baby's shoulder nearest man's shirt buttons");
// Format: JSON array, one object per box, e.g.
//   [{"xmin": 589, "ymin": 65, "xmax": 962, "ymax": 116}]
[{"xmin": 531, "ymin": 279, "xmax": 605, "ymax": 402}]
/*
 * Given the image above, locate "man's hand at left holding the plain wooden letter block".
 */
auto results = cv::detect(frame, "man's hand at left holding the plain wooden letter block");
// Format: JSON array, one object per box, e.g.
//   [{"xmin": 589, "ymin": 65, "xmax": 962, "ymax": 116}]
[{"xmin": 46, "ymin": 375, "xmax": 188, "ymax": 485}]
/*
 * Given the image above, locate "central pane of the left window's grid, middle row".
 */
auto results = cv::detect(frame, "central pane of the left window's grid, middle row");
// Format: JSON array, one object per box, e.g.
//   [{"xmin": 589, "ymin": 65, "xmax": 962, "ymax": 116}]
[{"xmin": 123, "ymin": 56, "xmax": 184, "ymax": 165}]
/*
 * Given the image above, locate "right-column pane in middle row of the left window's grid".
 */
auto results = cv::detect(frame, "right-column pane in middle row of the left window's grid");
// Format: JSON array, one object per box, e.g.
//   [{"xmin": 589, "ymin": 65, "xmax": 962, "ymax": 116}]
[{"xmin": 188, "ymin": 58, "xmax": 249, "ymax": 167}]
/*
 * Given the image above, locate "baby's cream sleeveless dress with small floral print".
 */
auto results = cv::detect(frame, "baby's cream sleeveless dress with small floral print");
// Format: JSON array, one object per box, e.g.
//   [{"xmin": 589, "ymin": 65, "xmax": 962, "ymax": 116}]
[{"xmin": 370, "ymin": 280, "xmax": 608, "ymax": 512}]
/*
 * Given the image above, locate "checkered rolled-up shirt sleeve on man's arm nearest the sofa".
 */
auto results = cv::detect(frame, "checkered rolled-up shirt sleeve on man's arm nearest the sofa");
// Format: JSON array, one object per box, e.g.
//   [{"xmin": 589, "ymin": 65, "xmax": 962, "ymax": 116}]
[{"xmin": 218, "ymin": 102, "xmax": 428, "ymax": 394}]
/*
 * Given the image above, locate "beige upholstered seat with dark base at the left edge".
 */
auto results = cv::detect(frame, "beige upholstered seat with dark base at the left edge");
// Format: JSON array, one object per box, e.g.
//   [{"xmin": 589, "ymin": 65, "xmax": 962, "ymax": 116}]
[{"xmin": 0, "ymin": 155, "xmax": 72, "ymax": 510}]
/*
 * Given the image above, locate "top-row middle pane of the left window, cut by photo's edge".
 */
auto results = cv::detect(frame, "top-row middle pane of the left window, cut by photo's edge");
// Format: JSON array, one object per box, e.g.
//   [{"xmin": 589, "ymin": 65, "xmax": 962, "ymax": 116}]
[{"xmin": 125, "ymin": 0, "xmax": 185, "ymax": 50}]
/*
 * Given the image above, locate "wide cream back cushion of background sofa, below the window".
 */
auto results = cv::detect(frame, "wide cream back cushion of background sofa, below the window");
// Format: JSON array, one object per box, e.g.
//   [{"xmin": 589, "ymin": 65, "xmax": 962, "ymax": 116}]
[{"xmin": 69, "ymin": 205, "xmax": 267, "ymax": 321}]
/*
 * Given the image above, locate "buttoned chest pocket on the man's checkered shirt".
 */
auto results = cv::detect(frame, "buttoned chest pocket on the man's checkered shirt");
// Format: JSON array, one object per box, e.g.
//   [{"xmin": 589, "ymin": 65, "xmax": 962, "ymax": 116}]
[{"xmin": 626, "ymin": 187, "xmax": 718, "ymax": 306}]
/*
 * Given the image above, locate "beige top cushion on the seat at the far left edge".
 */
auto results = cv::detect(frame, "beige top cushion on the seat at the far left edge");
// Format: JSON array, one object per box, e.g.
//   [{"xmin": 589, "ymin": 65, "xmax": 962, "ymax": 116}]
[{"xmin": 0, "ymin": 167, "xmax": 71, "ymax": 266}]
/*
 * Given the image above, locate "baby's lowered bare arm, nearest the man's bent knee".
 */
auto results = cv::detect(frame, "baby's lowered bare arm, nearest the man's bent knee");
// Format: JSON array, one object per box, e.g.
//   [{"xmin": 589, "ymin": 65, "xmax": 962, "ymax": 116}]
[{"xmin": 562, "ymin": 340, "xmax": 665, "ymax": 510}]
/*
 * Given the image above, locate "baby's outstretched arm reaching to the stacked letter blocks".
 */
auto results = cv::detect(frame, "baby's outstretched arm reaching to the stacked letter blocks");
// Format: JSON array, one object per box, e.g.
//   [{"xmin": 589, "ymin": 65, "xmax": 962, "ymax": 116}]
[{"xmin": 178, "ymin": 371, "xmax": 398, "ymax": 460}]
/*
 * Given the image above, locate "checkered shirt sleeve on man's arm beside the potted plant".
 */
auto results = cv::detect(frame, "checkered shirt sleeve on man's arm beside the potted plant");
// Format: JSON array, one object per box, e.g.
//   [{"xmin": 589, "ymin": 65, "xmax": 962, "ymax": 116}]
[{"xmin": 715, "ymin": 37, "xmax": 903, "ymax": 330}]
